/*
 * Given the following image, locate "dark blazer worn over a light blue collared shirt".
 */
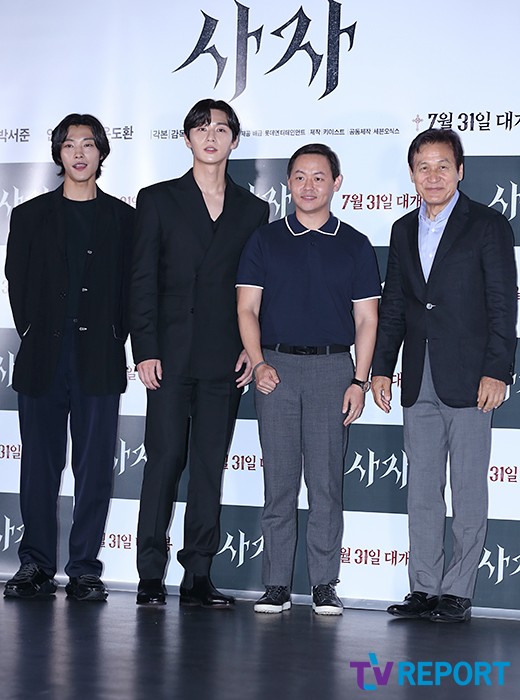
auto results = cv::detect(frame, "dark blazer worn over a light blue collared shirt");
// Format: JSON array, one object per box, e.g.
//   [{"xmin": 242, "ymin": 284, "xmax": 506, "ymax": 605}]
[{"xmin": 372, "ymin": 193, "xmax": 517, "ymax": 408}]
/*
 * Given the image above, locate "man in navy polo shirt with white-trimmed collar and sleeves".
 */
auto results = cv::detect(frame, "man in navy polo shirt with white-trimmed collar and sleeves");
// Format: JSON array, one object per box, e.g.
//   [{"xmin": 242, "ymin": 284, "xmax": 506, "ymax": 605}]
[{"xmin": 237, "ymin": 144, "xmax": 380, "ymax": 615}]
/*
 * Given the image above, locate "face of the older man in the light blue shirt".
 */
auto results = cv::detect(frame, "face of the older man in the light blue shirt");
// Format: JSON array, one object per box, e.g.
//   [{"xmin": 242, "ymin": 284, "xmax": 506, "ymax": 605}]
[{"xmin": 410, "ymin": 143, "xmax": 463, "ymax": 218}]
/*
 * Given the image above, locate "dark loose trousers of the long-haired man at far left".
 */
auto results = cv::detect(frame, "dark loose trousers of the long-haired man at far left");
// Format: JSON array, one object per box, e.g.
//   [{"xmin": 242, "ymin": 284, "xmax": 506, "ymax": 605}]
[{"xmin": 18, "ymin": 321, "xmax": 119, "ymax": 576}]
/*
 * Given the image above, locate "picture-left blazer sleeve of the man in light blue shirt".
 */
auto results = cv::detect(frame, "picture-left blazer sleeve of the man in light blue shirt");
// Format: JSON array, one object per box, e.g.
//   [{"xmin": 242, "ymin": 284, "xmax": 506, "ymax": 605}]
[{"xmin": 372, "ymin": 225, "xmax": 406, "ymax": 377}]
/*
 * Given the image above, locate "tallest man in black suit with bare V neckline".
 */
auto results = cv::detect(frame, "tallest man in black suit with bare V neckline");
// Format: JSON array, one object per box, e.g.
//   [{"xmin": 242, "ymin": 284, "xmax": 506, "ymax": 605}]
[{"xmin": 131, "ymin": 99, "xmax": 269, "ymax": 608}]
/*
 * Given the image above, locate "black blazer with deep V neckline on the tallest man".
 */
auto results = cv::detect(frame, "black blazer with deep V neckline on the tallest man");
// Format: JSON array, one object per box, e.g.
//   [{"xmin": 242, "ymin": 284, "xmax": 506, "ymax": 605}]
[{"xmin": 130, "ymin": 170, "xmax": 269, "ymax": 379}]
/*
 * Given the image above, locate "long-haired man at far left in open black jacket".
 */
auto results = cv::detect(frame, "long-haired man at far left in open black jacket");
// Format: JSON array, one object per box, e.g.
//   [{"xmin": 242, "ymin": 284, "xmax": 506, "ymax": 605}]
[{"xmin": 4, "ymin": 114, "xmax": 134, "ymax": 601}]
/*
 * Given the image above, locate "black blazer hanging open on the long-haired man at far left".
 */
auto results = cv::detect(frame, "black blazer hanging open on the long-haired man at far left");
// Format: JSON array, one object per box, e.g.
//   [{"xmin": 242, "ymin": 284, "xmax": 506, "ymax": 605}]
[{"xmin": 5, "ymin": 186, "xmax": 135, "ymax": 396}]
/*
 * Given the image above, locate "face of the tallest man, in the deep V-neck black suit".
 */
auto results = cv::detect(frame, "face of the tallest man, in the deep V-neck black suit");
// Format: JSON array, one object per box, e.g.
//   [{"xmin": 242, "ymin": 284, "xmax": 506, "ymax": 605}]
[{"xmin": 184, "ymin": 109, "xmax": 237, "ymax": 165}]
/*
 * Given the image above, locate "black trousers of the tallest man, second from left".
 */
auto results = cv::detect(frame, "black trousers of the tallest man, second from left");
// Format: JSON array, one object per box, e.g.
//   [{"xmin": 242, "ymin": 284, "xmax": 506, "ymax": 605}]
[{"xmin": 137, "ymin": 376, "xmax": 241, "ymax": 579}]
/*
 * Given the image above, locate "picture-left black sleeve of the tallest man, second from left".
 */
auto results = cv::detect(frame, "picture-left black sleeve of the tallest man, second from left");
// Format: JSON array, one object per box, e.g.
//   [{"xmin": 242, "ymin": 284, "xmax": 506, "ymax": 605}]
[{"xmin": 130, "ymin": 190, "xmax": 161, "ymax": 364}]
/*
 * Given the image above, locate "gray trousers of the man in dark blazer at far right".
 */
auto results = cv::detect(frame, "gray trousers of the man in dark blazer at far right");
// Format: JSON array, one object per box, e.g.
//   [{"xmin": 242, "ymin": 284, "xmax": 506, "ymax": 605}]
[{"xmin": 403, "ymin": 351, "xmax": 492, "ymax": 598}]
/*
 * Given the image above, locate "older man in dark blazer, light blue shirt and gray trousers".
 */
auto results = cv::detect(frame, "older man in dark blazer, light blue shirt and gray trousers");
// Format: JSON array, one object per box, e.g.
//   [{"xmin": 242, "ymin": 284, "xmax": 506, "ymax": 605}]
[{"xmin": 372, "ymin": 129, "xmax": 517, "ymax": 622}]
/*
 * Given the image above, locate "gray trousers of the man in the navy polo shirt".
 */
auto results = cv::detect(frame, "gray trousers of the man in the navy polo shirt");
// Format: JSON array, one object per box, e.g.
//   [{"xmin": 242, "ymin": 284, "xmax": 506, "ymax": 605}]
[{"xmin": 255, "ymin": 350, "xmax": 353, "ymax": 587}]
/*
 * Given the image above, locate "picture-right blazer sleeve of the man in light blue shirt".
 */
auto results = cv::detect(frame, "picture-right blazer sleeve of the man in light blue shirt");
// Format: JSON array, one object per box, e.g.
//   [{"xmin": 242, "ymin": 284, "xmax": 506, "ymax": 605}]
[{"xmin": 481, "ymin": 214, "xmax": 518, "ymax": 384}]
